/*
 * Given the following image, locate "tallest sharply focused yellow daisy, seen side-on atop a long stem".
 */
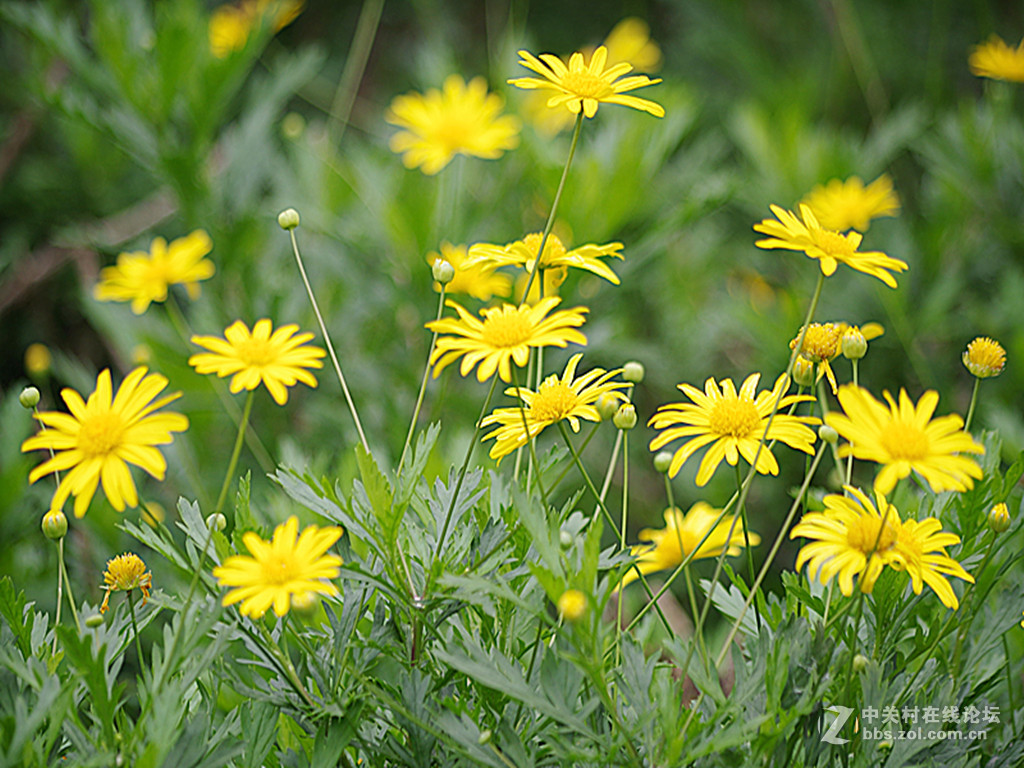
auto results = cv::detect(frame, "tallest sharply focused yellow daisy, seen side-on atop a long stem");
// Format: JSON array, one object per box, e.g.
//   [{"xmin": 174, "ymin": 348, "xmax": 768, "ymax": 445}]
[{"xmin": 508, "ymin": 45, "xmax": 665, "ymax": 118}]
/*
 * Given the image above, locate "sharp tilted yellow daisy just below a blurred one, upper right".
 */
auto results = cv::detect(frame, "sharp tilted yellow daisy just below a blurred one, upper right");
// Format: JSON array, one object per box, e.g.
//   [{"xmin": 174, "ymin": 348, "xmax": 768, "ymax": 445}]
[{"xmin": 754, "ymin": 204, "xmax": 906, "ymax": 288}]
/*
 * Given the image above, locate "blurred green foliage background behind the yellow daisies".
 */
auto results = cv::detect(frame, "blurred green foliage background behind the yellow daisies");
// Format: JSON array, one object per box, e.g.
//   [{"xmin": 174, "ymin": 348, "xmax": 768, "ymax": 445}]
[{"xmin": 0, "ymin": 0, "xmax": 1024, "ymax": 606}]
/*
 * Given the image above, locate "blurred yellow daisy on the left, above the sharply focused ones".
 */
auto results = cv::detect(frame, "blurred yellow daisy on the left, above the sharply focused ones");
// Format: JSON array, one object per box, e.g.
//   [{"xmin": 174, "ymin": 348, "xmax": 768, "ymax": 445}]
[{"xmin": 94, "ymin": 229, "xmax": 214, "ymax": 314}]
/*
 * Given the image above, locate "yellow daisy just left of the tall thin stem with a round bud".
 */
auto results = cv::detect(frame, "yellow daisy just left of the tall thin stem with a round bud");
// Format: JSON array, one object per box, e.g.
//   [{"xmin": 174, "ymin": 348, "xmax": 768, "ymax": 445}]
[{"xmin": 188, "ymin": 318, "xmax": 327, "ymax": 406}]
